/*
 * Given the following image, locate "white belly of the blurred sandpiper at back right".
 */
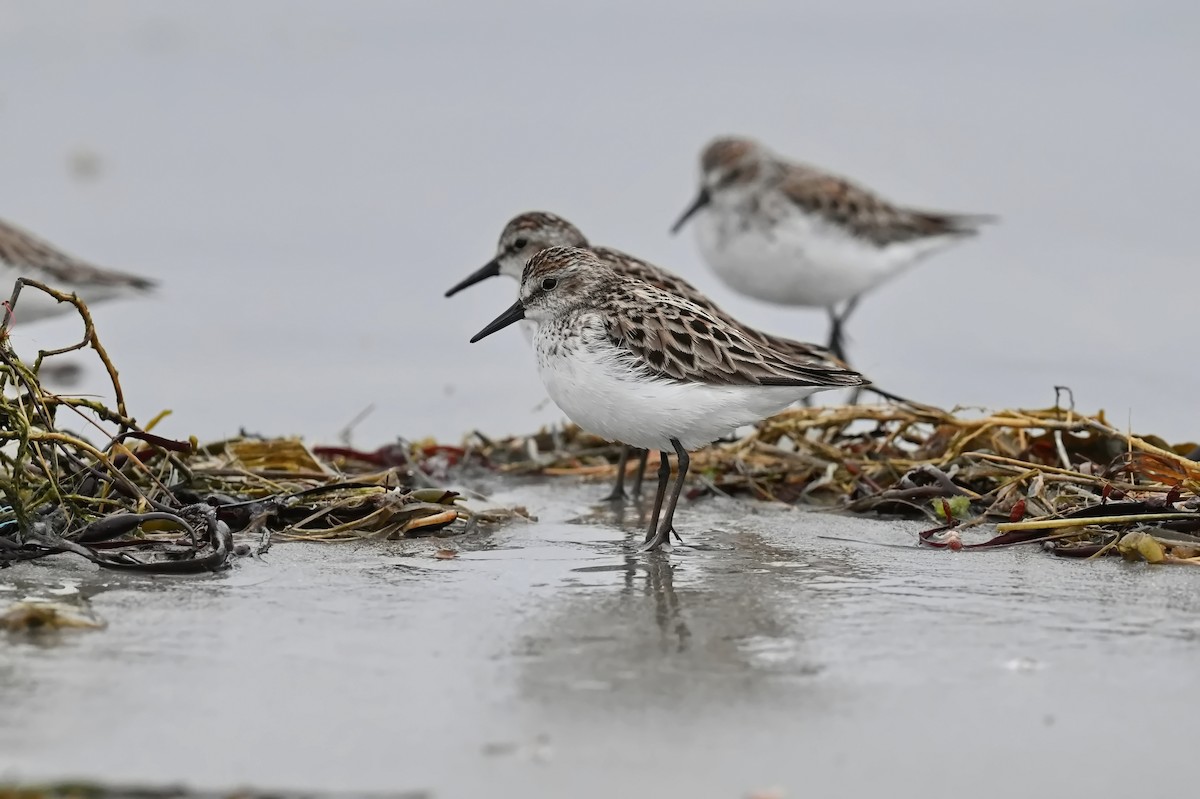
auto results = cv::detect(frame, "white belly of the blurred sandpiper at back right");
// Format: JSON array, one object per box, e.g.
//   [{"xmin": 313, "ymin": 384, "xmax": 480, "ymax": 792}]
[{"xmin": 696, "ymin": 209, "xmax": 950, "ymax": 307}]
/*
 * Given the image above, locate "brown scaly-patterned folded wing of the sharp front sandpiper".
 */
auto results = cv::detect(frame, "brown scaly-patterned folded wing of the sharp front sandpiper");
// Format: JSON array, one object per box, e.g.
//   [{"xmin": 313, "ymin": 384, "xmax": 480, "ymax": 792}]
[{"xmin": 604, "ymin": 282, "xmax": 866, "ymax": 388}]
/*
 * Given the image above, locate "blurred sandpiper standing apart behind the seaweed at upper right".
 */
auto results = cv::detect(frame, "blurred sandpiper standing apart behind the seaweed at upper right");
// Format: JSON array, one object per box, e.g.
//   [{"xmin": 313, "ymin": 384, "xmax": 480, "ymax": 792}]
[{"xmin": 671, "ymin": 137, "xmax": 992, "ymax": 359}]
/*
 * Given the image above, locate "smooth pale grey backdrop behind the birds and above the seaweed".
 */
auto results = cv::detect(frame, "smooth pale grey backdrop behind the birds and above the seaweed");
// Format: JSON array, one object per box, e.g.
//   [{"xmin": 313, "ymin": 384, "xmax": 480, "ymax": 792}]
[{"xmin": 0, "ymin": 0, "xmax": 1200, "ymax": 444}]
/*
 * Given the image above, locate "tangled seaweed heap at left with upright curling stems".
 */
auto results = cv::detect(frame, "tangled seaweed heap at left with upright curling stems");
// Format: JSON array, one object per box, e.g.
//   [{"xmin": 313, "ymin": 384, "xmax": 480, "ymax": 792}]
[{"xmin": 0, "ymin": 280, "xmax": 504, "ymax": 573}]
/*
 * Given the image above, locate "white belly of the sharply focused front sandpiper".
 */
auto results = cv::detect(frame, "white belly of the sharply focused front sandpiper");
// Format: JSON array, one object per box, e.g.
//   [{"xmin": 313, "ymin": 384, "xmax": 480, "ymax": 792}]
[{"xmin": 534, "ymin": 335, "xmax": 814, "ymax": 452}]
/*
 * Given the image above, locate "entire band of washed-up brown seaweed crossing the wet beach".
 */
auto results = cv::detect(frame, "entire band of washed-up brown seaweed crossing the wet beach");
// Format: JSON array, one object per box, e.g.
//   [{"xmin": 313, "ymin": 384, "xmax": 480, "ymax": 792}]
[{"xmin": 0, "ymin": 280, "xmax": 1200, "ymax": 573}]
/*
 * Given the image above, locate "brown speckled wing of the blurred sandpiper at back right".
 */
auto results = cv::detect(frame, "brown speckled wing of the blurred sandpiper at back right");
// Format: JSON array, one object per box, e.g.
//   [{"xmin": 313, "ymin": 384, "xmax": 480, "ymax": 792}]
[{"xmin": 779, "ymin": 164, "xmax": 991, "ymax": 247}]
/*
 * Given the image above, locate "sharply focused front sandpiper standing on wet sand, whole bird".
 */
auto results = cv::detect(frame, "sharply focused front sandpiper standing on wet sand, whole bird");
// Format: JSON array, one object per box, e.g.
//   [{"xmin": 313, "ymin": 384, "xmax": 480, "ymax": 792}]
[{"xmin": 470, "ymin": 247, "xmax": 865, "ymax": 549}]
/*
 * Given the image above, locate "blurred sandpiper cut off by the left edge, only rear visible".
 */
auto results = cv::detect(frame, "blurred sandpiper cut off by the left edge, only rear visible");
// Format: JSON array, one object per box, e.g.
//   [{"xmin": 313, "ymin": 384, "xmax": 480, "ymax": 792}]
[{"xmin": 0, "ymin": 220, "xmax": 155, "ymax": 323}]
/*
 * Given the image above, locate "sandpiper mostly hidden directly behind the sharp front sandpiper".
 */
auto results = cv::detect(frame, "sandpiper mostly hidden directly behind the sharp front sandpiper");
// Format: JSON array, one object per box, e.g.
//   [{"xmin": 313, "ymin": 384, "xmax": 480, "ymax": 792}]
[{"xmin": 446, "ymin": 211, "xmax": 849, "ymax": 499}]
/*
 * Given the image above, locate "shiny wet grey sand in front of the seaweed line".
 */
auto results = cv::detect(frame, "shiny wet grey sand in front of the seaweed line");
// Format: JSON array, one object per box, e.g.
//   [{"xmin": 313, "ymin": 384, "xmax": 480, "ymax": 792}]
[{"xmin": 0, "ymin": 475, "xmax": 1200, "ymax": 798}]
